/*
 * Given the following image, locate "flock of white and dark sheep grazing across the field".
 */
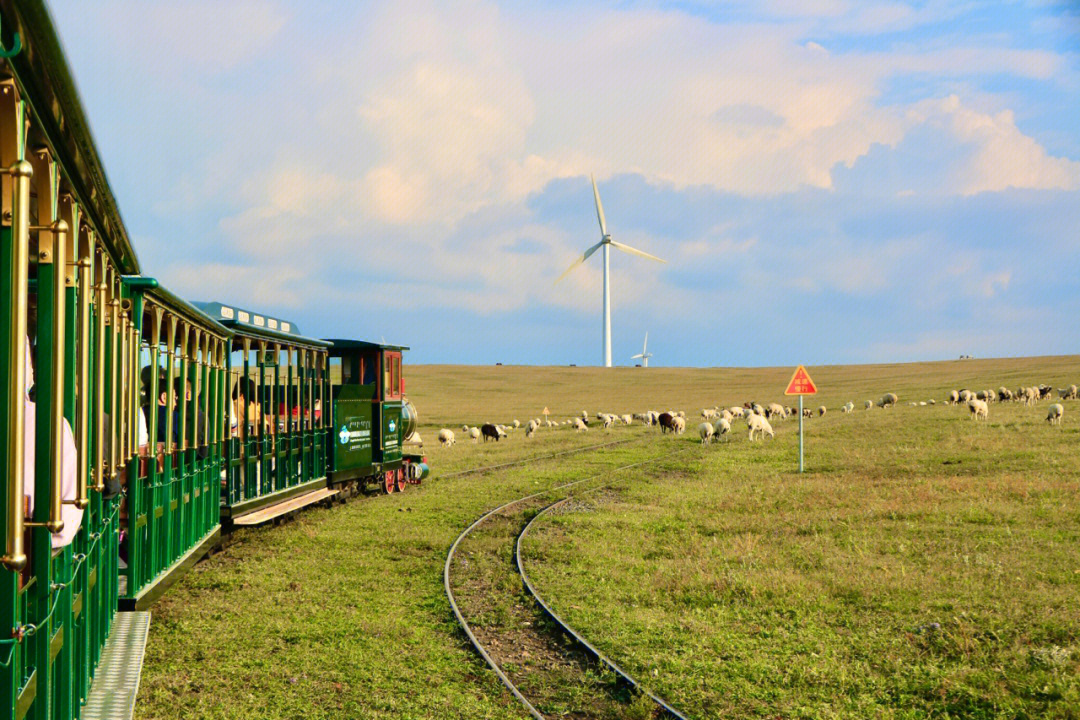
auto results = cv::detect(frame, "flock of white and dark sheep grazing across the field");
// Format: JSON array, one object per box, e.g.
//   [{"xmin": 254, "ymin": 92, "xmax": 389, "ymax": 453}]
[{"xmin": 425, "ymin": 385, "xmax": 1080, "ymax": 446}]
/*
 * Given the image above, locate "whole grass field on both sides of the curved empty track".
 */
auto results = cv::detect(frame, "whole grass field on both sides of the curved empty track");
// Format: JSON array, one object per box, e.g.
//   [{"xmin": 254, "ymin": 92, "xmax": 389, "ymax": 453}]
[{"xmin": 138, "ymin": 357, "xmax": 1080, "ymax": 718}]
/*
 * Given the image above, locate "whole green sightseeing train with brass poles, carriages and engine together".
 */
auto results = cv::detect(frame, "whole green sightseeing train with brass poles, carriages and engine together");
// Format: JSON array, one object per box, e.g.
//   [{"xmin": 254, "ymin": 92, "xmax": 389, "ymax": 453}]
[{"xmin": 0, "ymin": 0, "xmax": 429, "ymax": 720}]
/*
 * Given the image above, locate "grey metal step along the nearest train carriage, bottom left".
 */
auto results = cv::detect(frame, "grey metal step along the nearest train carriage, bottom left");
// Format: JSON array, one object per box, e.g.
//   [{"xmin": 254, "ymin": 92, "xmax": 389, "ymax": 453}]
[{"xmin": 82, "ymin": 611, "xmax": 150, "ymax": 720}]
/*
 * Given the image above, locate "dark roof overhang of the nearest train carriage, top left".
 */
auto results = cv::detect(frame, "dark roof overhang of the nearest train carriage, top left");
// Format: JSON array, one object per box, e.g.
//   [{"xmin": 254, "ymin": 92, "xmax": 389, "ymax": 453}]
[{"xmin": 0, "ymin": 0, "xmax": 139, "ymax": 274}]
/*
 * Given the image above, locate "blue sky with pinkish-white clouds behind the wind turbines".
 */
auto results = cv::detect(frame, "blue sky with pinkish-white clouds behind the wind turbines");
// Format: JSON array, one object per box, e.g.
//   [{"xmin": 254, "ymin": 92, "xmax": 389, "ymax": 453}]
[{"xmin": 50, "ymin": 0, "xmax": 1080, "ymax": 366}]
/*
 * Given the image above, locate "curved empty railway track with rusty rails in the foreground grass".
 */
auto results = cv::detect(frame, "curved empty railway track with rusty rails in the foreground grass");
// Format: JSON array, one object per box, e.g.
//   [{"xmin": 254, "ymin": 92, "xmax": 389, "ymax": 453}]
[{"xmin": 443, "ymin": 443, "xmax": 689, "ymax": 720}]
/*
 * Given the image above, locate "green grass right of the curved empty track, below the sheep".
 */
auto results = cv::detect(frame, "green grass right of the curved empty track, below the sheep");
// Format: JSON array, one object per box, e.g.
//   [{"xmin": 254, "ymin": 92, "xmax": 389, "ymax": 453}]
[{"xmin": 526, "ymin": 403, "xmax": 1080, "ymax": 718}]
